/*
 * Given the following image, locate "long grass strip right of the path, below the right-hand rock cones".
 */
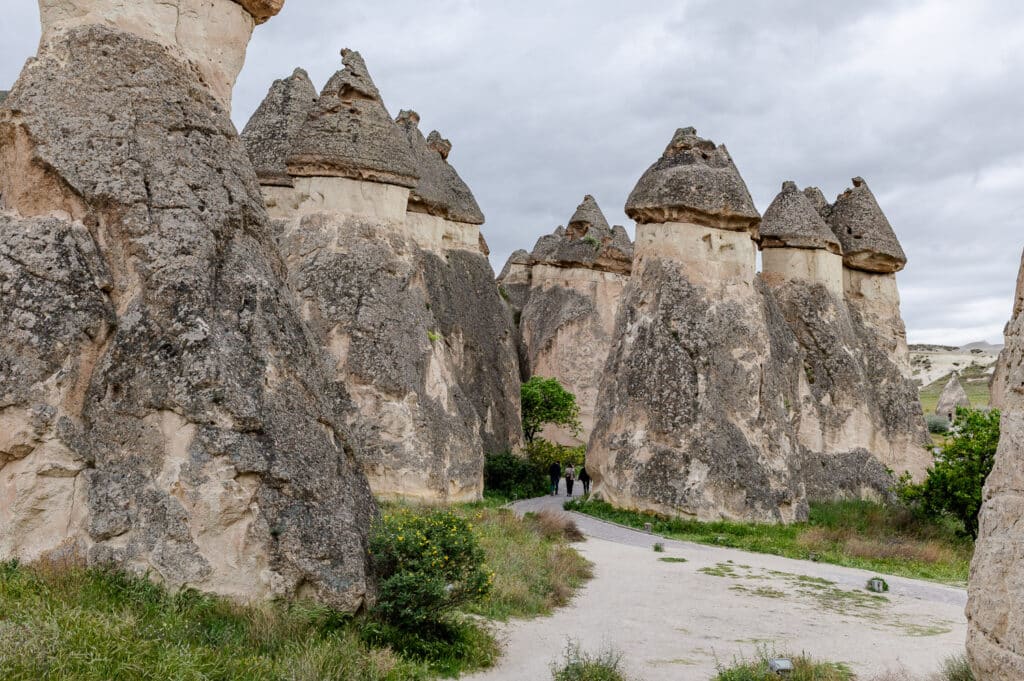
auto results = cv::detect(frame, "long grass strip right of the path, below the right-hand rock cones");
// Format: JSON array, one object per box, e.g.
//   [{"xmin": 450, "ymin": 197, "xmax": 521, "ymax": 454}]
[{"xmin": 565, "ymin": 493, "xmax": 974, "ymax": 586}]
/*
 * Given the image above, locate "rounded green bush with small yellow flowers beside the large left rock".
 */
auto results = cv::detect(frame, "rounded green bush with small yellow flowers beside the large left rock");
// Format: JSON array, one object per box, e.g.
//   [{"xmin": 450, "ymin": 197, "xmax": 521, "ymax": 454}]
[{"xmin": 370, "ymin": 509, "xmax": 495, "ymax": 633}]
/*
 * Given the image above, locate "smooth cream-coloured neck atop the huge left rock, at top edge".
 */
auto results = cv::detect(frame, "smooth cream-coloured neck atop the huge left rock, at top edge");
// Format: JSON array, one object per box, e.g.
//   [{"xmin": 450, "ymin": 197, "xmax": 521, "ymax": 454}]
[{"xmin": 39, "ymin": 0, "xmax": 264, "ymax": 111}]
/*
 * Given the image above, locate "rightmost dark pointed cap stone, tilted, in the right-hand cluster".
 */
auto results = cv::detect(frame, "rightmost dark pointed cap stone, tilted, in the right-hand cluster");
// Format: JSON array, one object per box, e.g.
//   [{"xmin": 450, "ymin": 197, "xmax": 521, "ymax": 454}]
[{"xmin": 828, "ymin": 177, "xmax": 906, "ymax": 273}]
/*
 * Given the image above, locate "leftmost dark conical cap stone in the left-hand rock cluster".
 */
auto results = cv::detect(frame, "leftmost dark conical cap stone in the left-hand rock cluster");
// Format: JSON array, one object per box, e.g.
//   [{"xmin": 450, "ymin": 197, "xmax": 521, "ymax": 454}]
[{"xmin": 242, "ymin": 69, "xmax": 316, "ymax": 186}]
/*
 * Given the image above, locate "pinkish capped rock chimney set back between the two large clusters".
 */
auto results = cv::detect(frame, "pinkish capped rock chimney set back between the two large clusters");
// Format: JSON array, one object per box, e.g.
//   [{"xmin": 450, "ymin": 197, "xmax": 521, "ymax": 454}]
[{"xmin": 512, "ymin": 196, "xmax": 633, "ymax": 445}]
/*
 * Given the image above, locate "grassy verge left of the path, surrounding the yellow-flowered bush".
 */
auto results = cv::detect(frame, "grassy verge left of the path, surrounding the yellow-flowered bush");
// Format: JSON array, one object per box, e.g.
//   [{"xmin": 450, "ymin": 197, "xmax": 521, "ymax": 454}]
[{"xmin": 0, "ymin": 503, "xmax": 590, "ymax": 681}]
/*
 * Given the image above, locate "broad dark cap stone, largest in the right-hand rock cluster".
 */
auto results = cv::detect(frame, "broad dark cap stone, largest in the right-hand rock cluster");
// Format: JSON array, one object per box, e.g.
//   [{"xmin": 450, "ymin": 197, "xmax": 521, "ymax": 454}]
[{"xmin": 626, "ymin": 128, "xmax": 761, "ymax": 232}]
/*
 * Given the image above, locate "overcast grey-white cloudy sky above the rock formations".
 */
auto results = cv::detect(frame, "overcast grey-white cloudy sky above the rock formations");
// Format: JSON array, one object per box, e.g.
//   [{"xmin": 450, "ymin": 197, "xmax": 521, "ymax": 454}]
[{"xmin": 0, "ymin": 0, "xmax": 1024, "ymax": 344}]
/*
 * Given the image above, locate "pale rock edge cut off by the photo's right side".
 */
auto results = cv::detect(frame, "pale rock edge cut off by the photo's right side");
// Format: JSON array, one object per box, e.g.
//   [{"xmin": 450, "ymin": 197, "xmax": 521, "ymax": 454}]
[{"xmin": 967, "ymin": 249, "xmax": 1024, "ymax": 681}]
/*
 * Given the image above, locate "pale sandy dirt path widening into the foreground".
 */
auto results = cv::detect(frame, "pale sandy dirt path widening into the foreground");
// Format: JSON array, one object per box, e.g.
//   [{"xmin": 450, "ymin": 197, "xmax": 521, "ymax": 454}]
[{"xmin": 467, "ymin": 497, "xmax": 967, "ymax": 681}]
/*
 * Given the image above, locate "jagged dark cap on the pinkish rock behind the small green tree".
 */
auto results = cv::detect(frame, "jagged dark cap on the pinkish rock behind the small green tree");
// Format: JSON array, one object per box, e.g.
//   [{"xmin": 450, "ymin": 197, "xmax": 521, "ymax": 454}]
[{"xmin": 529, "ymin": 195, "xmax": 633, "ymax": 273}]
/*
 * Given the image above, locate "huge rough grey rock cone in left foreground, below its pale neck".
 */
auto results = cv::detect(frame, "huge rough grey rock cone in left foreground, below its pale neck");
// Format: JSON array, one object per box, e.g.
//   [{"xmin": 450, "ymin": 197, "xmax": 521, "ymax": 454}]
[{"xmin": 0, "ymin": 10, "xmax": 375, "ymax": 609}]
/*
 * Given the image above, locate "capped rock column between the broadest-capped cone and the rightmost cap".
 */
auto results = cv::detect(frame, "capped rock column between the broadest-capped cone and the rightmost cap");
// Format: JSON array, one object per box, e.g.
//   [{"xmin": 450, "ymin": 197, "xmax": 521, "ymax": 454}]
[{"xmin": 761, "ymin": 182, "xmax": 931, "ymax": 485}]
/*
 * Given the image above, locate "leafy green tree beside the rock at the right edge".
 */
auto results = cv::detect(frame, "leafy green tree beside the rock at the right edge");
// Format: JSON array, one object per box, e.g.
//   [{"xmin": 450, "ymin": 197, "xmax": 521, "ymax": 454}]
[{"xmin": 900, "ymin": 407, "xmax": 999, "ymax": 539}]
